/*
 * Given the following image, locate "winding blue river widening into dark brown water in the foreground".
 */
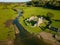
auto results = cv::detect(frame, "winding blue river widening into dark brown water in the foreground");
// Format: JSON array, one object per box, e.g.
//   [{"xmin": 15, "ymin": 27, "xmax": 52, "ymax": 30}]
[{"xmin": 13, "ymin": 9, "xmax": 51, "ymax": 45}]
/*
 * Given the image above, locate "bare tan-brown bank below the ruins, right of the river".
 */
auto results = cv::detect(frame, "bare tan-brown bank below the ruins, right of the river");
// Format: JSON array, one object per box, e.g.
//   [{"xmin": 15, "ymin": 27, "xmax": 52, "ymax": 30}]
[{"xmin": 37, "ymin": 32, "xmax": 60, "ymax": 45}]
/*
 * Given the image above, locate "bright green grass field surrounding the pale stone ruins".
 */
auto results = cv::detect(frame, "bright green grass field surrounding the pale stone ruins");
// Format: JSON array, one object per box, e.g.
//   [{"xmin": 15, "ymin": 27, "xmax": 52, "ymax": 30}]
[{"xmin": 19, "ymin": 7, "xmax": 60, "ymax": 34}]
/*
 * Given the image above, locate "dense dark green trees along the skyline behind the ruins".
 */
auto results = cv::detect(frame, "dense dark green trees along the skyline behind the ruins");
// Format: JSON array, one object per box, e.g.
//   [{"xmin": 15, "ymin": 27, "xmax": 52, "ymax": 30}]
[{"xmin": 27, "ymin": 0, "xmax": 60, "ymax": 9}]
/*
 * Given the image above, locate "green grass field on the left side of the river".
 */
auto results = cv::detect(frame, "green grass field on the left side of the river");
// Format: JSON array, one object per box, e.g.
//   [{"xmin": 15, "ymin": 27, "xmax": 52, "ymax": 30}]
[{"xmin": 0, "ymin": 8, "xmax": 17, "ymax": 41}]
